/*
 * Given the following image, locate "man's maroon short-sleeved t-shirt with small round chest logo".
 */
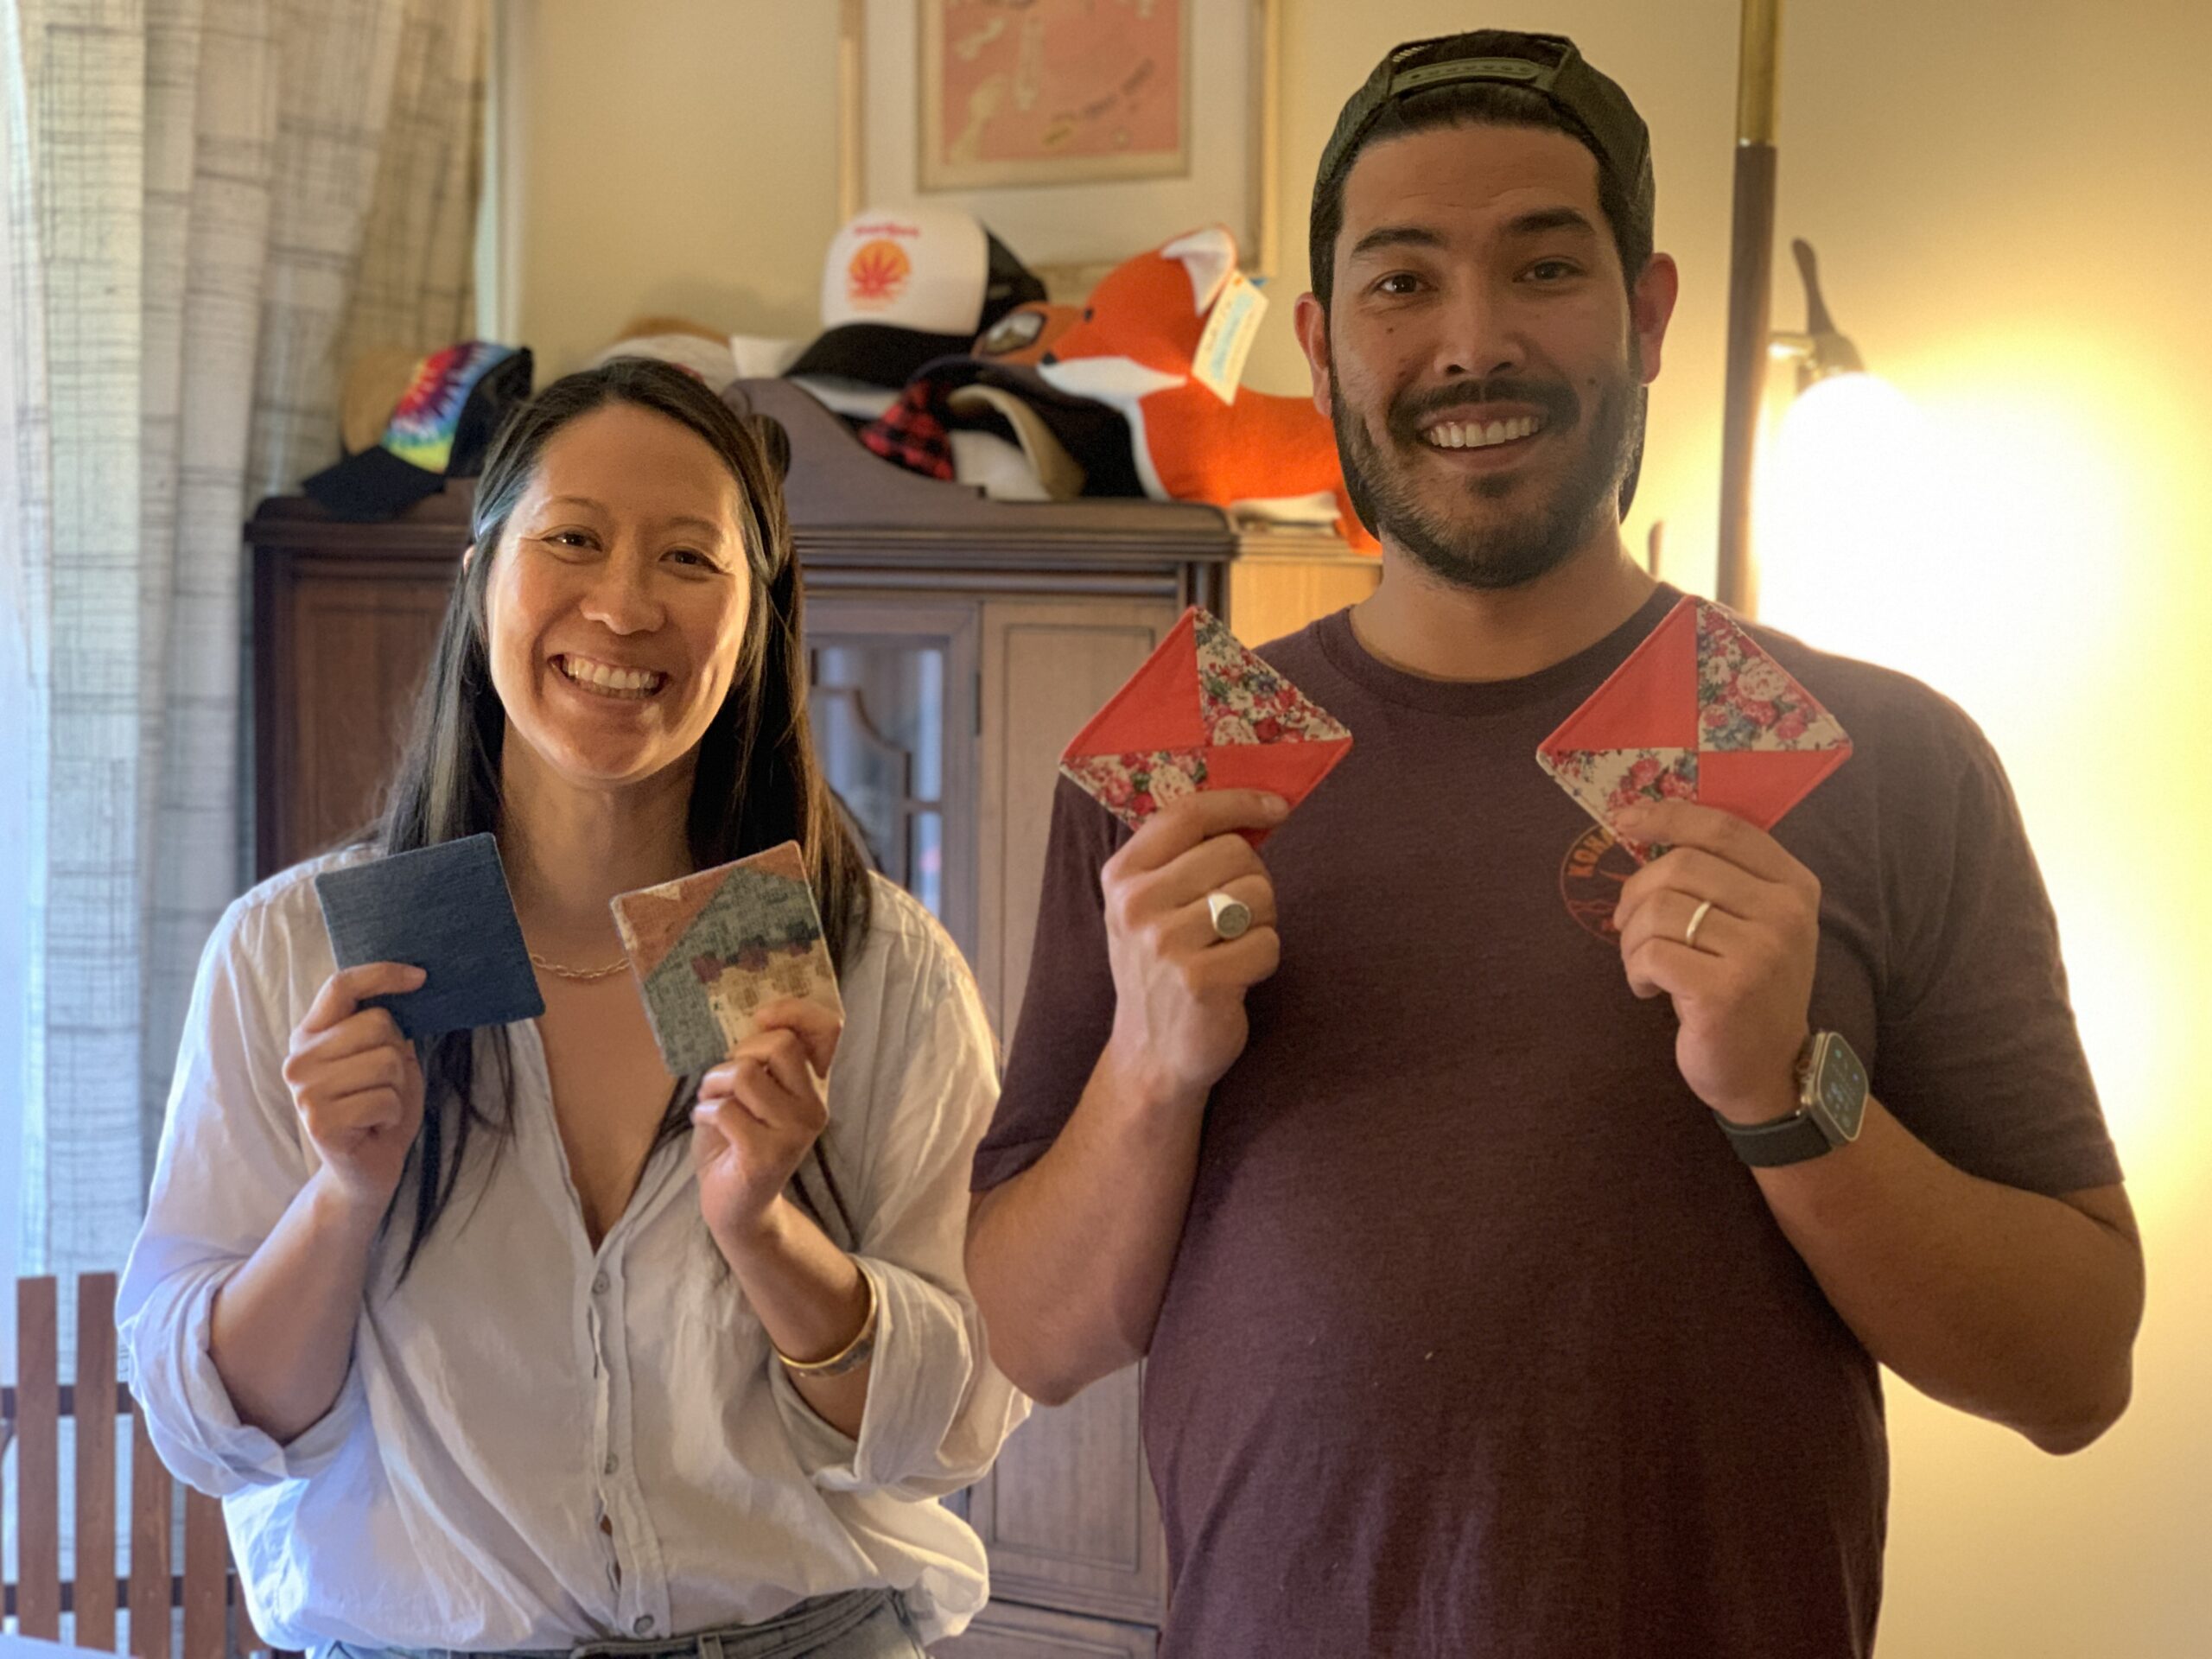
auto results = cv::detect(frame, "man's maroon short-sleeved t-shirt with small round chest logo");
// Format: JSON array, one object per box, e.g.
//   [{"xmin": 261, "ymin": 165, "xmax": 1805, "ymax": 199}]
[{"xmin": 976, "ymin": 588, "xmax": 2119, "ymax": 1659}]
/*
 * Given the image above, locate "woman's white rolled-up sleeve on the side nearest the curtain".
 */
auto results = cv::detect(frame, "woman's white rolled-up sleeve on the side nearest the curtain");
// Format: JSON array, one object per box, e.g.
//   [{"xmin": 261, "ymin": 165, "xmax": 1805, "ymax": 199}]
[{"xmin": 118, "ymin": 896, "xmax": 363, "ymax": 1497}]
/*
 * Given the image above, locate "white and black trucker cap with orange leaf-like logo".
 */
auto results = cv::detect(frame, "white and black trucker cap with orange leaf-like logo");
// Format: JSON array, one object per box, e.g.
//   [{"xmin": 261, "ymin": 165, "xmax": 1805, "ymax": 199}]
[{"xmin": 785, "ymin": 206, "xmax": 1044, "ymax": 387}]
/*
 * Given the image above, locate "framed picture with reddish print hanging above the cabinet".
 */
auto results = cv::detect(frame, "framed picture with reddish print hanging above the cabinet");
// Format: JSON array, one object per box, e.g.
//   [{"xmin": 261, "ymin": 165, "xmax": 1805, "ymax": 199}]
[{"xmin": 838, "ymin": 0, "xmax": 1279, "ymax": 296}]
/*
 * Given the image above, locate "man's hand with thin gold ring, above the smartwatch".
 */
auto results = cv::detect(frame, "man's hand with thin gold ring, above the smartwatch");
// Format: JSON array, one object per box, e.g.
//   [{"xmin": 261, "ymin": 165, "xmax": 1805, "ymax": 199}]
[{"xmin": 1612, "ymin": 801, "xmax": 1821, "ymax": 1123}]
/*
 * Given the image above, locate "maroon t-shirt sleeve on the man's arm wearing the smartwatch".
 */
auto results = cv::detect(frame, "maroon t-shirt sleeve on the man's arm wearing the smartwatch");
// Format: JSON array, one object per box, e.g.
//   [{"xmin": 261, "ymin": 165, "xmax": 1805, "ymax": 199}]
[{"xmin": 1872, "ymin": 702, "xmax": 2121, "ymax": 1194}]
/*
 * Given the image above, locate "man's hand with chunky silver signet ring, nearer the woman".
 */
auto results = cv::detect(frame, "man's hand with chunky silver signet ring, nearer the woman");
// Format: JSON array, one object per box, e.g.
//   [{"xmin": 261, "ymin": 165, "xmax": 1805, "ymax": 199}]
[{"xmin": 1099, "ymin": 790, "xmax": 1289, "ymax": 1119}]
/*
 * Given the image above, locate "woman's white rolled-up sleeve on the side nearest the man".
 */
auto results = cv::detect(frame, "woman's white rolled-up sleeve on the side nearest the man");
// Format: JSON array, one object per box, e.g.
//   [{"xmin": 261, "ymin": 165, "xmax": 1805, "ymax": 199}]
[{"xmin": 770, "ymin": 925, "xmax": 1028, "ymax": 1497}]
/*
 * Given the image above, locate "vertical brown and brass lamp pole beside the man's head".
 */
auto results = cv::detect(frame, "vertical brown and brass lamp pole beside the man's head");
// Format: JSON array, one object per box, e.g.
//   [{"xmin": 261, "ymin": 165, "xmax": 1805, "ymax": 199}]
[{"xmin": 1714, "ymin": 0, "xmax": 1783, "ymax": 615}]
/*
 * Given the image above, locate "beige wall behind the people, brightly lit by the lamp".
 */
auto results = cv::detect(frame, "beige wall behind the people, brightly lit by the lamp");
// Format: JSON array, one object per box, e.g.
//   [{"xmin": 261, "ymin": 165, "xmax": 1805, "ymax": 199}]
[{"xmin": 509, "ymin": 0, "xmax": 2212, "ymax": 1659}]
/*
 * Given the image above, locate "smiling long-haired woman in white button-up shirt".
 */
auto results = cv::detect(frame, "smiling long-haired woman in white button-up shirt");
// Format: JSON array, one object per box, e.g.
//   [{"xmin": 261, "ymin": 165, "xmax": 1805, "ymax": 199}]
[{"xmin": 122, "ymin": 359, "xmax": 1024, "ymax": 1659}]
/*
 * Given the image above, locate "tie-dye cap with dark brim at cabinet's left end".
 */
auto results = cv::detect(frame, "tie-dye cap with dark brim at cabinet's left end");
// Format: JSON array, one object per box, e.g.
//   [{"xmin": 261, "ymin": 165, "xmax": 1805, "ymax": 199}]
[{"xmin": 301, "ymin": 340, "xmax": 533, "ymax": 520}]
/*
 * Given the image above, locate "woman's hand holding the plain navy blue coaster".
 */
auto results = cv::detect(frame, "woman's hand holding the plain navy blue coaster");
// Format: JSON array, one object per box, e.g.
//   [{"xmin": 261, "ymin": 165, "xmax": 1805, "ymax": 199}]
[{"xmin": 283, "ymin": 963, "xmax": 427, "ymax": 1214}]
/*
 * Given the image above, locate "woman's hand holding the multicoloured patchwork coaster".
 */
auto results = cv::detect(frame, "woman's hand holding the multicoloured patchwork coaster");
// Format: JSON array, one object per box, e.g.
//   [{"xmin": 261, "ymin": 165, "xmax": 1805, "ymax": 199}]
[{"xmin": 692, "ymin": 998, "xmax": 842, "ymax": 1259}]
